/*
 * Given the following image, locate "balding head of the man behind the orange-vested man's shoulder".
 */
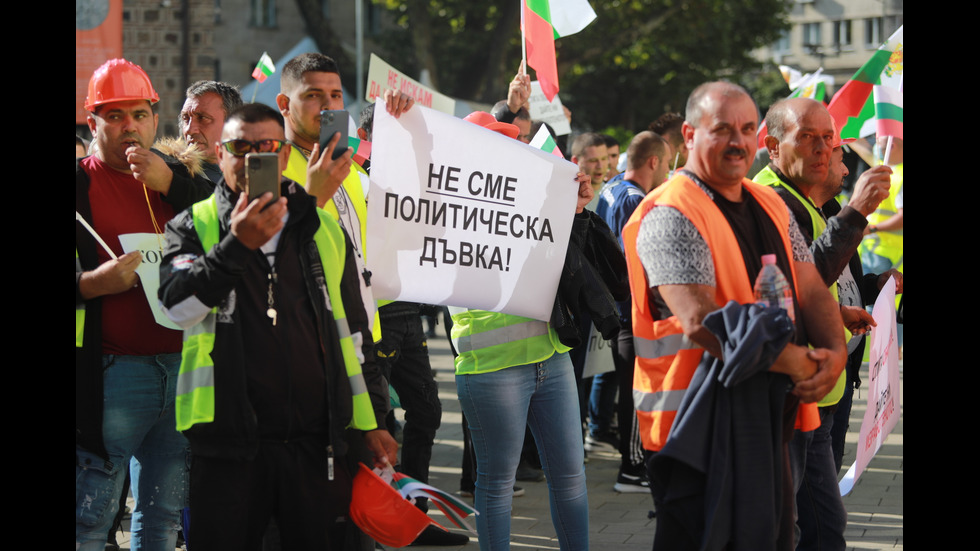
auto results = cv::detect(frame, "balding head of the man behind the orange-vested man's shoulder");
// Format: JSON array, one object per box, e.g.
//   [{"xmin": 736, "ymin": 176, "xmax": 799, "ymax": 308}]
[{"xmin": 765, "ymin": 98, "xmax": 835, "ymax": 194}]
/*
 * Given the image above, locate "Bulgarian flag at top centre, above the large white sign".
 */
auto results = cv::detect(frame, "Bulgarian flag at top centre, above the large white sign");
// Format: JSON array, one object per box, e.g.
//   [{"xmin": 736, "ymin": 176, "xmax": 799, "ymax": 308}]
[{"xmin": 521, "ymin": 0, "xmax": 595, "ymax": 101}]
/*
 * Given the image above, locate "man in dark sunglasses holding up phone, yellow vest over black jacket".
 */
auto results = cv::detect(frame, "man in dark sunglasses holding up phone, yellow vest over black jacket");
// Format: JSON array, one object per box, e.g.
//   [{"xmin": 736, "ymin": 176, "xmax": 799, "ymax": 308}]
[{"xmin": 160, "ymin": 104, "xmax": 397, "ymax": 549}]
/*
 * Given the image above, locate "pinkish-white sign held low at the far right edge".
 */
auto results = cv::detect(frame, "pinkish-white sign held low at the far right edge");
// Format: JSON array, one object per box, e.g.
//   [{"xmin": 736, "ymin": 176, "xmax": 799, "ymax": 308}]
[{"xmin": 840, "ymin": 278, "xmax": 901, "ymax": 495}]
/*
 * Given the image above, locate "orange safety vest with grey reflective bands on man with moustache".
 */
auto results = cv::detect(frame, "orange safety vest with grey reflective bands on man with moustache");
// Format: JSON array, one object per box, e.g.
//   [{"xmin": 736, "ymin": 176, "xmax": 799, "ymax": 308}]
[{"xmin": 623, "ymin": 174, "xmax": 820, "ymax": 451}]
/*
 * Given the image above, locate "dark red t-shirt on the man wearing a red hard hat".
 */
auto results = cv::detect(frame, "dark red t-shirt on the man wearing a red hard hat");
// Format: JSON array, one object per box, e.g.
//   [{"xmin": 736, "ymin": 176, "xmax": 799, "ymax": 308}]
[{"xmin": 81, "ymin": 156, "xmax": 182, "ymax": 356}]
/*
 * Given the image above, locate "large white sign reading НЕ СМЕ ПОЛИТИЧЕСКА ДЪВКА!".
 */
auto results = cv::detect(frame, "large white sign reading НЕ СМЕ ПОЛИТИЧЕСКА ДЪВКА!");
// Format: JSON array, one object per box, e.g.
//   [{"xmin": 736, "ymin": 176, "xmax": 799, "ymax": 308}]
[{"xmin": 367, "ymin": 100, "xmax": 578, "ymax": 321}]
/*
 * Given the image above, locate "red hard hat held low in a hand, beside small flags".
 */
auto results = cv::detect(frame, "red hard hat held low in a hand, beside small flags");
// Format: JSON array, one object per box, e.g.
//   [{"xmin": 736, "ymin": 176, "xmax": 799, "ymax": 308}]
[{"xmin": 350, "ymin": 463, "xmax": 445, "ymax": 547}]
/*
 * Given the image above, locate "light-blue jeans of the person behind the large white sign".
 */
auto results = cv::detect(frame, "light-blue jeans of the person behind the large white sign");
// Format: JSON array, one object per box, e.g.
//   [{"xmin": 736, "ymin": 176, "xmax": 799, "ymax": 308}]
[{"xmin": 456, "ymin": 354, "xmax": 589, "ymax": 551}]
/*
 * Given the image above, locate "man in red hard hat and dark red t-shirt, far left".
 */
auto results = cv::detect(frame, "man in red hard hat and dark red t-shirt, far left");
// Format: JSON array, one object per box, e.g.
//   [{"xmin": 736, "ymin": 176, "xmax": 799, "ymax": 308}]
[{"xmin": 75, "ymin": 59, "xmax": 212, "ymax": 551}]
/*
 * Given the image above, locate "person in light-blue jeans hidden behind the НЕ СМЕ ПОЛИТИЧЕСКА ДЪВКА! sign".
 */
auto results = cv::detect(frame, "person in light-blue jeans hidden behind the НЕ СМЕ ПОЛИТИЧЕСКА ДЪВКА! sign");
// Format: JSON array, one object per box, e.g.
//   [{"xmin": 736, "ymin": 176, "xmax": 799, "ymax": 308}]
[{"xmin": 452, "ymin": 112, "xmax": 592, "ymax": 551}]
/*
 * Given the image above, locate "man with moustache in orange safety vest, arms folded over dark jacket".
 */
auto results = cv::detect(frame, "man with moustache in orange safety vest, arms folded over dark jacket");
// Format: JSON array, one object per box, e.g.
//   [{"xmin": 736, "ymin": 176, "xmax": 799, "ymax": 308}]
[{"xmin": 623, "ymin": 82, "xmax": 847, "ymax": 549}]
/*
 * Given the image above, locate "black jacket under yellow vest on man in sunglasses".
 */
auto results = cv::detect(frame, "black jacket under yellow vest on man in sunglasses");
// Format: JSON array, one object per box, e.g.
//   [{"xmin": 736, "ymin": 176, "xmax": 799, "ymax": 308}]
[{"xmin": 160, "ymin": 180, "xmax": 388, "ymax": 459}]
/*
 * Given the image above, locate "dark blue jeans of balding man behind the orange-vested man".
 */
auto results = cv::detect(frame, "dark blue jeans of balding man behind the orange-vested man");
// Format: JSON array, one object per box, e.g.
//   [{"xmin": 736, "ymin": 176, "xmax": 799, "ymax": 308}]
[{"xmin": 789, "ymin": 406, "xmax": 847, "ymax": 551}]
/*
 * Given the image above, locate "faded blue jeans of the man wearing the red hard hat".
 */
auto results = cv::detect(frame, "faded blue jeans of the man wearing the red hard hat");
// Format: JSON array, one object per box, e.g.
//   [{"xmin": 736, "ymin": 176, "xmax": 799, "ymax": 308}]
[{"xmin": 75, "ymin": 353, "xmax": 190, "ymax": 551}]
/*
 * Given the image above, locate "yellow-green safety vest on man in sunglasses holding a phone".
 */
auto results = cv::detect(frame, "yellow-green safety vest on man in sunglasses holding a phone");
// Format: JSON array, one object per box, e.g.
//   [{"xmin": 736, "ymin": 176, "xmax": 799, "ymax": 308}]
[{"xmin": 176, "ymin": 195, "xmax": 378, "ymax": 430}]
